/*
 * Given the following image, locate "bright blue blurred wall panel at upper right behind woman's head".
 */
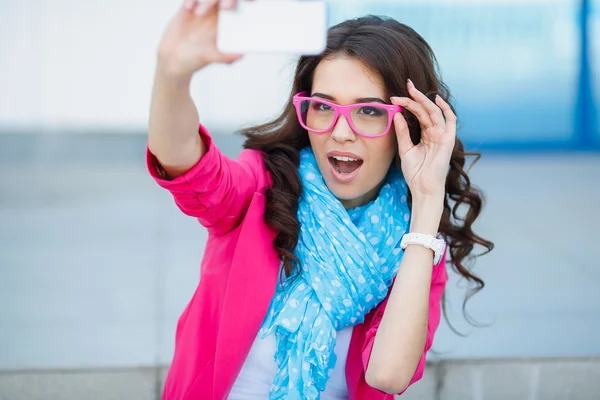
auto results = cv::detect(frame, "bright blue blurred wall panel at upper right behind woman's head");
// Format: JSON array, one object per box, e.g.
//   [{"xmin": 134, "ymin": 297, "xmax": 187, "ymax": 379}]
[{"xmin": 330, "ymin": 0, "xmax": 600, "ymax": 150}]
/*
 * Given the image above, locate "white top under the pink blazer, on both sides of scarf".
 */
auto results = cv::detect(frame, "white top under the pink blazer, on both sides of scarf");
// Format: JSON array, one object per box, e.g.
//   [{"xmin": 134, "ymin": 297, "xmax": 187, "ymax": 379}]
[{"xmin": 227, "ymin": 326, "xmax": 353, "ymax": 400}]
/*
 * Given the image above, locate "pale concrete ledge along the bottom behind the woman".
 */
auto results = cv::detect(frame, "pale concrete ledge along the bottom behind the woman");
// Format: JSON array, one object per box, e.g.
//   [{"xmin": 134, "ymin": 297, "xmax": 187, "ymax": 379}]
[{"xmin": 0, "ymin": 358, "xmax": 600, "ymax": 400}]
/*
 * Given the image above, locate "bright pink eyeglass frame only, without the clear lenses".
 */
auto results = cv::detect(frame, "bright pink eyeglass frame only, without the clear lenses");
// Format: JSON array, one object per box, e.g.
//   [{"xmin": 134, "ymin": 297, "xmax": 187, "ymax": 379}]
[{"xmin": 292, "ymin": 92, "xmax": 402, "ymax": 139}]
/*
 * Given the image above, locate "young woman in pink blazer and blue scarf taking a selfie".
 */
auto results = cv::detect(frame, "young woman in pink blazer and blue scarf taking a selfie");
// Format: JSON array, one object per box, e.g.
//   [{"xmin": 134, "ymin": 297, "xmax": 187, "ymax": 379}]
[{"xmin": 148, "ymin": 0, "xmax": 492, "ymax": 400}]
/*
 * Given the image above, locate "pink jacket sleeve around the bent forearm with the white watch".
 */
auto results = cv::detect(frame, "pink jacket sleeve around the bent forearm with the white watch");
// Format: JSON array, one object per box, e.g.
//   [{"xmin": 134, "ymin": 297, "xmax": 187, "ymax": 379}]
[{"xmin": 362, "ymin": 250, "xmax": 448, "ymax": 394}]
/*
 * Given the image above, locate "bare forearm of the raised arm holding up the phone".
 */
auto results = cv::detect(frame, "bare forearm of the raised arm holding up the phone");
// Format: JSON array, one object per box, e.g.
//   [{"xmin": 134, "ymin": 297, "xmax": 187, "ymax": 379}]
[{"xmin": 148, "ymin": 68, "xmax": 206, "ymax": 178}]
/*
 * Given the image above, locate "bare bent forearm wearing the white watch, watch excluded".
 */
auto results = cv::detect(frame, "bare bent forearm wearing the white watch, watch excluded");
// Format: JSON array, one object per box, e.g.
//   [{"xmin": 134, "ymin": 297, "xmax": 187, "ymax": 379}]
[{"xmin": 367, "ymin": 197, "xmax": 443, "ymax": 393}]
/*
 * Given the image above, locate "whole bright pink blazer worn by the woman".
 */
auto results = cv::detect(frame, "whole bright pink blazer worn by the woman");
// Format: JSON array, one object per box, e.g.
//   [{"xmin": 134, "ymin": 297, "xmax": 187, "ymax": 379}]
[{"xmin": 147, "ymin": 127, "xmax": 448, "ymax": 400}]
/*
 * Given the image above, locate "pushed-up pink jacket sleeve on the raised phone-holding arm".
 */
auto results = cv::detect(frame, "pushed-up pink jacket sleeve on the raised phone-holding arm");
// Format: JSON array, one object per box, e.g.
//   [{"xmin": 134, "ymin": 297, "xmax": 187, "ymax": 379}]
[{"xmin": 146, "ymin": 126, "xmax": 262, "ymax": 235}]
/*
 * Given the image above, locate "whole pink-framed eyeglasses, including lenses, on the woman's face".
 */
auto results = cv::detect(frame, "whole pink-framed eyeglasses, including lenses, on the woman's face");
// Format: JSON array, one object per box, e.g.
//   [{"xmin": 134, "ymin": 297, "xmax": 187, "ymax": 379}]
[{"xmin": 293, "ymin": 92, "xmax": 402, "ymax": 138}]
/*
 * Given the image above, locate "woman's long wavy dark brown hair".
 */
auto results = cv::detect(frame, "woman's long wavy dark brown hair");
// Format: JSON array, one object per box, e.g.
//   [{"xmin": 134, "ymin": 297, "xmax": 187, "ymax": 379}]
[{"xmin": 242, "ymin": 16, "xmax": 494, "ymax": 322}]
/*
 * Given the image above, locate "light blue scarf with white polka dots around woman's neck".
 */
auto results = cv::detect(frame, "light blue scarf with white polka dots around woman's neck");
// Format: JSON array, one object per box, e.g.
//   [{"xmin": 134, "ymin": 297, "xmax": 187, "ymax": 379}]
[{"xmin": 259, "ymin": 148, "xmax": 410, "ymax": 400}]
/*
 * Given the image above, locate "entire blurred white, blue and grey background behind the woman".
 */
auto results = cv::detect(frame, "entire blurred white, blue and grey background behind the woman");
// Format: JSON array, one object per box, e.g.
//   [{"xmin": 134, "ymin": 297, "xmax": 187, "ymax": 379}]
[{"xmin": 0, "ymin": 0, "xmax": 600, "ymax": 400}]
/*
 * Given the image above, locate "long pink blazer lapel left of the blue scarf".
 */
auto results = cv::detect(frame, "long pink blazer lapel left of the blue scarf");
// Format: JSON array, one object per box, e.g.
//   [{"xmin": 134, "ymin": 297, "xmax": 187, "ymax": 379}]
[{"xmin": 214, "ymin": 193, "xmax": 280, "ymax": 400}]
